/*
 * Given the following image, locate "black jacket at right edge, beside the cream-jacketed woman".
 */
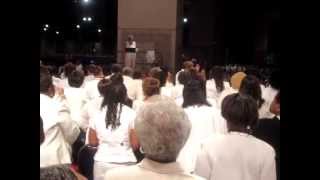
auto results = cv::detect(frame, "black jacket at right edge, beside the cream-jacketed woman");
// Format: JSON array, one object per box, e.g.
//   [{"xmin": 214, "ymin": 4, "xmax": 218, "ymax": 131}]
[{"xmin": 253, "ymin": 117, "xmax": 280, "ymax": 180}]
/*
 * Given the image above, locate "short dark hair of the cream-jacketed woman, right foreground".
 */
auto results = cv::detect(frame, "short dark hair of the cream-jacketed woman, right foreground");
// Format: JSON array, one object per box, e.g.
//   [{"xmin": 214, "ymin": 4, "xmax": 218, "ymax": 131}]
[{"xmin": 221, "ymin": 93, "xmax": 259, "ymax": 133}]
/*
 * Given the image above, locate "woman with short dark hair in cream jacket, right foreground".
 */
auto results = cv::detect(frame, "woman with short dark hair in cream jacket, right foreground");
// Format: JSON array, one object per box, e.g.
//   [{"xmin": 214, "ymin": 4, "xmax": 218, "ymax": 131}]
[{"xmin": 195, "ymin": 93, "xmax": 276, "ymax": 180}]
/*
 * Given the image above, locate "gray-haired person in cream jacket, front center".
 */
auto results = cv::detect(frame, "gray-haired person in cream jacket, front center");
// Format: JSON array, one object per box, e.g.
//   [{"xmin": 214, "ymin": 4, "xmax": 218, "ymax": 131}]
[{"xmin": 105, "ymin": 99, "xmax": 202, "ymax": 180}]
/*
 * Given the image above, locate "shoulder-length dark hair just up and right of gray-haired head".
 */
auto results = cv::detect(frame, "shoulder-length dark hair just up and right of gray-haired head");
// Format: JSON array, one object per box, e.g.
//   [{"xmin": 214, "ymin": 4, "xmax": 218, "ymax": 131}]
[{"xmin": 182, "ymin": 79, "xmax": 211, "ymax": 108}]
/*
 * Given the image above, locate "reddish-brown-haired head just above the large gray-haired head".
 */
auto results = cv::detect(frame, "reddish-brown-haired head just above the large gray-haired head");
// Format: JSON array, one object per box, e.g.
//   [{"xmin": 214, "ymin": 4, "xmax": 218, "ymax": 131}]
[{"xmin": 142, "ymin": 77, "xmax": 160, "ymax": 97}]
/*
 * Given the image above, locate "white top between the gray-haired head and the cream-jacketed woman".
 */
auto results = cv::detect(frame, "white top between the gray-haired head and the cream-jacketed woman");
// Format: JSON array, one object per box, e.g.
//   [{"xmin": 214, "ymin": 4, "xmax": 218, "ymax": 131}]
[{"xmin": 177, "ymin": 105, "xmax": 226, "ymax": 172}]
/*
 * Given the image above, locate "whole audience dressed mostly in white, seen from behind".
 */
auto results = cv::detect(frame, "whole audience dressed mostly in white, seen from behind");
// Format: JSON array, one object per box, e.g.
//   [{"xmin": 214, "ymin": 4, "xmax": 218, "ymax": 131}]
[{"xmin": 40, "ymin": 59, "xmax": 280, "ymax": 180}]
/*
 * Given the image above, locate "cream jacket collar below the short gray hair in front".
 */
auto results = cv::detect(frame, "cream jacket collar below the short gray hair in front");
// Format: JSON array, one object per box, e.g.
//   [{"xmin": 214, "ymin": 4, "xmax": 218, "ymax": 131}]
[{"xmin": 138, "ymin": 158, "xmax": 185, "ymax": 174}]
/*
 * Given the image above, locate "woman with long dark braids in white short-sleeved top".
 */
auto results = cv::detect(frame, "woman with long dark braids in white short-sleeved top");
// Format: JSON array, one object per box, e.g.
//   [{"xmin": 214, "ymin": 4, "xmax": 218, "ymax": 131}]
[{"xmin": 89, "ymin": 80, "xmax": 136, "ymax": 180}]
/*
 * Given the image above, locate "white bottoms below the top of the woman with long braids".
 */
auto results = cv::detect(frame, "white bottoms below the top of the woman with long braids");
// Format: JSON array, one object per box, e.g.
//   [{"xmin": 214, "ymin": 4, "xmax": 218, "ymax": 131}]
[{"xmin": 93, "ymin": 161, "xmax": 135, "ymax": 180}]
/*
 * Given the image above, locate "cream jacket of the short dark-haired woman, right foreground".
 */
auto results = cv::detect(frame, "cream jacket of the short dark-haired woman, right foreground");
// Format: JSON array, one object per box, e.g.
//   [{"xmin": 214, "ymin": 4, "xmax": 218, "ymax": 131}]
[{"xmin": 195, "ymin": 132, "xmax": 276, "ymax": 180}]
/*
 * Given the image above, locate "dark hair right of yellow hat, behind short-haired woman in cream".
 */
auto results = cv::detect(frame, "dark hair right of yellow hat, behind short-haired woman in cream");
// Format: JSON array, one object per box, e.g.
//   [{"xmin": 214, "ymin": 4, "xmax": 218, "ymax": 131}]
[{"xmin": 239, "ymin": 75, "xmax": 264, "ymax": 108}]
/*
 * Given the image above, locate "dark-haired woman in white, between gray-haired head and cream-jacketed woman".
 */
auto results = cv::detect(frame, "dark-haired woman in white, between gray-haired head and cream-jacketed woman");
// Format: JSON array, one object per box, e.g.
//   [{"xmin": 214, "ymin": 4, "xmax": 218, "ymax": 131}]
[{"xmin": 178, "ymin": 79, "xmax": 226, "ymax": 173}]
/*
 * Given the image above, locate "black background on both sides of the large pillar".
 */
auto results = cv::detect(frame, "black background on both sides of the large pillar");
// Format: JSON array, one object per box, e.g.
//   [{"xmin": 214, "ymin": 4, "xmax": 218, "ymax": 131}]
[{"xmin": 40, "ymin": 0, "xmax": 280, "ymax": 67}]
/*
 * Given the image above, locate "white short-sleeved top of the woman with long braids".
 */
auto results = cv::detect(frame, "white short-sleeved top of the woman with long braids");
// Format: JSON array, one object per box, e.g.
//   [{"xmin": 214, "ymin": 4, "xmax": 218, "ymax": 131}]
[{"xmin": 90, "ymin": 105, "xmax": 136, "ymax": 163}]
